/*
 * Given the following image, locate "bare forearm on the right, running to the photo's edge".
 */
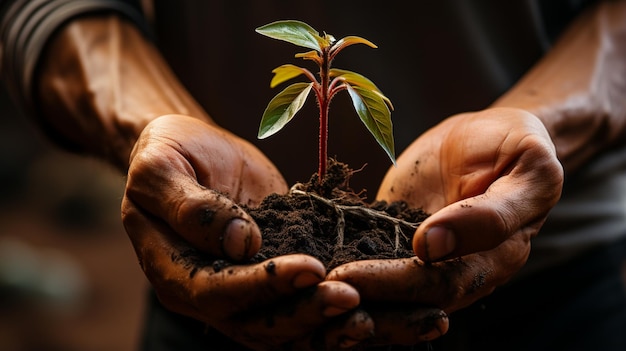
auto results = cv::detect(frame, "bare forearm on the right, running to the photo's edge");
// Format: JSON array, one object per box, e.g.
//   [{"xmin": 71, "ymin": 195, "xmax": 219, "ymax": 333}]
[{"xmin": 493, "ymin": 1, "xmax": 626, "ymax": 172}]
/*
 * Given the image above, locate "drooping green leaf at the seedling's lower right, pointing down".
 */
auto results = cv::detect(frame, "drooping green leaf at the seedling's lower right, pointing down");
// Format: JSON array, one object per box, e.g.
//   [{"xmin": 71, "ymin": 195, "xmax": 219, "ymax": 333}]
[{"xmin": 347, "ymin": 85, "xmax": 396, "ymax": 165}]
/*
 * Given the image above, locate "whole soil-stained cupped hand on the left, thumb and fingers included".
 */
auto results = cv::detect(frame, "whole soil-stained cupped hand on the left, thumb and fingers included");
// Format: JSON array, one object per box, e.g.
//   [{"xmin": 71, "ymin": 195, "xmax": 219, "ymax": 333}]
[{"xmin": 122, "ymin": 115, "xmax": 372, "ymax": 350}]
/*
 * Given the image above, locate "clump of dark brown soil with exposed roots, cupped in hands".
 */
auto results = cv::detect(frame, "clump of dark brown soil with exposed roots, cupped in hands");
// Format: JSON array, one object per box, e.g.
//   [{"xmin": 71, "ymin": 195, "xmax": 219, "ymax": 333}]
[{"xmin": 246, "ymin": 159, "xmax": 428, "ymax": 270}]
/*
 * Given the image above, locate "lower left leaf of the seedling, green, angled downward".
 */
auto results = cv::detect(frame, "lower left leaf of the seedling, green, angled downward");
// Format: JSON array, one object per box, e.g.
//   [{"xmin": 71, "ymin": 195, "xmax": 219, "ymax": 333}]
[{"xmin": 258, "ymin": 83, "xmax": 313, "ymax": 139}]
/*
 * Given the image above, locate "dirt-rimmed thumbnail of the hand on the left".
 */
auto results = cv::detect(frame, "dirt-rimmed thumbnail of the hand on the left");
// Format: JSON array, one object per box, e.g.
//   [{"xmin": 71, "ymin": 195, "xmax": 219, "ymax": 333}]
[{"xmin": 222, "ymin": 218, "xmax": 259, "ymax": 261}]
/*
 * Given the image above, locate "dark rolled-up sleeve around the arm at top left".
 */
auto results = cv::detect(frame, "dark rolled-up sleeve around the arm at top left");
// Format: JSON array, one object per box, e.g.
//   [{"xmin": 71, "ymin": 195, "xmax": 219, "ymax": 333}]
[{"xmin": 0, "ymin": 0, "xmax": 148, "ymax": 118}]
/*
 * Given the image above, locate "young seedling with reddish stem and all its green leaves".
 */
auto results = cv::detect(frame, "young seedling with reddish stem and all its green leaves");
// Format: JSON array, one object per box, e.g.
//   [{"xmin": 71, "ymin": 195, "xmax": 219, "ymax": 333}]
[{"xmin": 256, "ymin": 20, "xmax": 396, "ymax": 182}]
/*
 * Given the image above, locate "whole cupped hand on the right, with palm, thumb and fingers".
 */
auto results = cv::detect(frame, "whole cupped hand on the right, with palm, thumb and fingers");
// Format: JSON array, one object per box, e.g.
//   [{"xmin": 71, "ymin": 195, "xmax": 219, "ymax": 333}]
[{"xmin": 327, "ymin": 108, "xmax": 563, "ymax": 344}]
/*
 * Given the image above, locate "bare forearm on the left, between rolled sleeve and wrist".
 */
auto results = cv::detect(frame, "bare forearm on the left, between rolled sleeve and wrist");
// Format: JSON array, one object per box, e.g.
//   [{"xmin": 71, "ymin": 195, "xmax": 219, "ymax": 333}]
[{"xmin": 35, "ymin": 15, "xmax": 210, "ymax": 169}]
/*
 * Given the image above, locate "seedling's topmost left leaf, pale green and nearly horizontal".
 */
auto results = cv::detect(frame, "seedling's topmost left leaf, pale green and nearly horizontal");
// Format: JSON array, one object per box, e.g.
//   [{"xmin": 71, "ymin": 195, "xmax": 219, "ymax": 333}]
[{"xmin": 256, "ymin": 20, "xmax": 330, "ymax": 52}]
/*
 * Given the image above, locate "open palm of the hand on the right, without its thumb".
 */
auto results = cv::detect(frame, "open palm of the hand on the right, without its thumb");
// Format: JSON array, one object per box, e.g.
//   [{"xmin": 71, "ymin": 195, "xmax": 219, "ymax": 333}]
[{"xmin": 378, "ymin": 113, "xmax": 534, "ymax": 213}]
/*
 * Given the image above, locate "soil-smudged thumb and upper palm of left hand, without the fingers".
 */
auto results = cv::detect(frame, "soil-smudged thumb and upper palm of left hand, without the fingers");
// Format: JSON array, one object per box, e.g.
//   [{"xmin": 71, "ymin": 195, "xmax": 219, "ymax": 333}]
[{"xmin": 126, "ymin": 115, "xmax": 286, "ymax": 260}]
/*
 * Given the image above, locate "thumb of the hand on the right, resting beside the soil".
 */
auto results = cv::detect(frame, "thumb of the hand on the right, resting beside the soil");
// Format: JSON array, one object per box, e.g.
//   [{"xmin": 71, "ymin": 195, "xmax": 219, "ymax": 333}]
[{"xmin": 413, "ymin": 122, "xmax": 563, "ymax": 262}]
